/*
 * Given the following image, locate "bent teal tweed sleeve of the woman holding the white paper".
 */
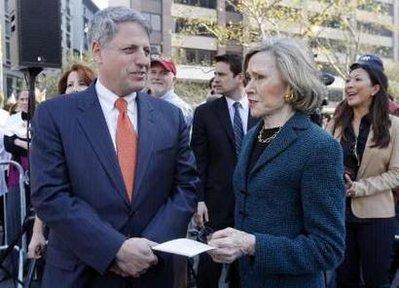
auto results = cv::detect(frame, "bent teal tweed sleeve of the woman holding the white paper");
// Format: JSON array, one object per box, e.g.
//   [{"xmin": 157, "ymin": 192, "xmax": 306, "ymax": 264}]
[{"xmin": 252, "ymin": 139, "xmax": 345, "ymax": 275}]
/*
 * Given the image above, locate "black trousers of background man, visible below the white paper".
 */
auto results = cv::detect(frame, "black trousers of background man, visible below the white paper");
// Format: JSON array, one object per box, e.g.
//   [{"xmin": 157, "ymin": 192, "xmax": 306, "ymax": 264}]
[{"xmin": 197, "ymin": 253, "xmax": 240, "ymax": 288}]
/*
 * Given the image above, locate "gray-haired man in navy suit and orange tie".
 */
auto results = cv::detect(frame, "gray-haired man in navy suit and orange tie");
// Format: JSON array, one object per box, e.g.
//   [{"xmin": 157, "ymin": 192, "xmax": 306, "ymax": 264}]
[{"xmin": 31, "ymin": 7, "xmax": 198, "ymax": 287}]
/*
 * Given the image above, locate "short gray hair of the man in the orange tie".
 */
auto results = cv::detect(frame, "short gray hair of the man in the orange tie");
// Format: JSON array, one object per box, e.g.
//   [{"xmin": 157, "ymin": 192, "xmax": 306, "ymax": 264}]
[{"xmin": 88, "ymin": 6, "xmax": 152, "ymax": 45}]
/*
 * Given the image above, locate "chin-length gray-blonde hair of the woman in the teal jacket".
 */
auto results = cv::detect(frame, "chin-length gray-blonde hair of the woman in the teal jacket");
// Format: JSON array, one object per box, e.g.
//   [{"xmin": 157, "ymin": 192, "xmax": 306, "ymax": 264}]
[{"xmin": 244, "ymin": 37, "xmax": 327, "ymax": 114}]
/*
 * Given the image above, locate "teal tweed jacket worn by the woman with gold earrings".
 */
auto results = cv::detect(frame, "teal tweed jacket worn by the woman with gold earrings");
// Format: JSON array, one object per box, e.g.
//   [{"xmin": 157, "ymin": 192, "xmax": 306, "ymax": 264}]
[{"xmin": 234, "ymin": 113, "xmax": 345, "ymax": 288}]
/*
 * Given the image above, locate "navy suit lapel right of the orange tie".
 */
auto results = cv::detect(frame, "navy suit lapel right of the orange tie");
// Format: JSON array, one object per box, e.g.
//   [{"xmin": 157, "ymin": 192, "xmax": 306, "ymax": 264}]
[{"xmin": 133, "ymin": 93, "xmax": 157, "ymax": 208}]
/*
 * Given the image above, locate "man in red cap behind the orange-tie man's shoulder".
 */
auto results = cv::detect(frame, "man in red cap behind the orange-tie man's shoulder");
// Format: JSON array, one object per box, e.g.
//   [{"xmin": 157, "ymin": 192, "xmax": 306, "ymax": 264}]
[{"xmin": 148, "ymin": 57, "xmax": 193, "ymax": 127}]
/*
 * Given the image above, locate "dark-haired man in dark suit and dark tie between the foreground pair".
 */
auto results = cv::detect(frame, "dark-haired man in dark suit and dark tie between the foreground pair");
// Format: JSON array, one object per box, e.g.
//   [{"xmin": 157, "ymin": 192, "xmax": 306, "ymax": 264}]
[{"xmin": 191, "ymin": 54, "xmax": 257, "ymax": 288}]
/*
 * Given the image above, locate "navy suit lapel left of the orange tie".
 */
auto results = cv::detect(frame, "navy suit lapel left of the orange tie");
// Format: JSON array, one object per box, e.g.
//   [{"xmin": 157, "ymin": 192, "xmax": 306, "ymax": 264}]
[{"xmin": 78, "ymin": 83, "xmax": 129, "ymax": 204}]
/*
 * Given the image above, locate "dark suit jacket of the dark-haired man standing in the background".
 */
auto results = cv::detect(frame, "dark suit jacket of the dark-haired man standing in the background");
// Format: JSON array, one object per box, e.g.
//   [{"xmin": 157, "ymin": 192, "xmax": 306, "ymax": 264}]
[{"xmin": 191, "ymin": 97, "xmax": 258, "ymax": 230}]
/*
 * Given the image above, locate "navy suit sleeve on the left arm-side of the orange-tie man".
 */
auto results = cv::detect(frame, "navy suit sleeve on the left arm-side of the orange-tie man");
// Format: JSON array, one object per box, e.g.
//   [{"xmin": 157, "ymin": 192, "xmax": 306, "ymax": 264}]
[{"xmin": 30, "ymin": 103, "xmax": 125, "ymax": 273}]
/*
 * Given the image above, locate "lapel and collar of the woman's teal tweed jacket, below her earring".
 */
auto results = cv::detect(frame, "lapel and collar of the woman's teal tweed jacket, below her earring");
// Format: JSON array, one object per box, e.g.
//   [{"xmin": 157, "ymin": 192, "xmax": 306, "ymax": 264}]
[{"xmin": 249, "ymin": 113, "xmax": 309, "ymax": 177}]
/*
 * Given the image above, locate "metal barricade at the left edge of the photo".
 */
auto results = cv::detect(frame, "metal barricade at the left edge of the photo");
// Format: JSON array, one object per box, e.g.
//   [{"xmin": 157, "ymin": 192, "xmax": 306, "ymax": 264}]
[{"xmin": 0, "ymin": 161, "xmax": 28, "ymax": 288}]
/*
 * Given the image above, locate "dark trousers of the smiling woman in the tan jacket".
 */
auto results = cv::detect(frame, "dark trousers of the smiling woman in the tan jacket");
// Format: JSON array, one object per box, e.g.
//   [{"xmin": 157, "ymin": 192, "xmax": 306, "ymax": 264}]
[{"xmin": 337, "ymin": 218, "xmax": 395, "ymax": 288}]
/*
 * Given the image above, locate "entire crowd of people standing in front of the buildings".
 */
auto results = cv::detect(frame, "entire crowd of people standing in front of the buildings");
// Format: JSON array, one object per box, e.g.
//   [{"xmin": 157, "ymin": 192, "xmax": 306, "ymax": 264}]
[{"xmin": 3, "ymin": 7, "xmax": 399, "ymax": 288}]
